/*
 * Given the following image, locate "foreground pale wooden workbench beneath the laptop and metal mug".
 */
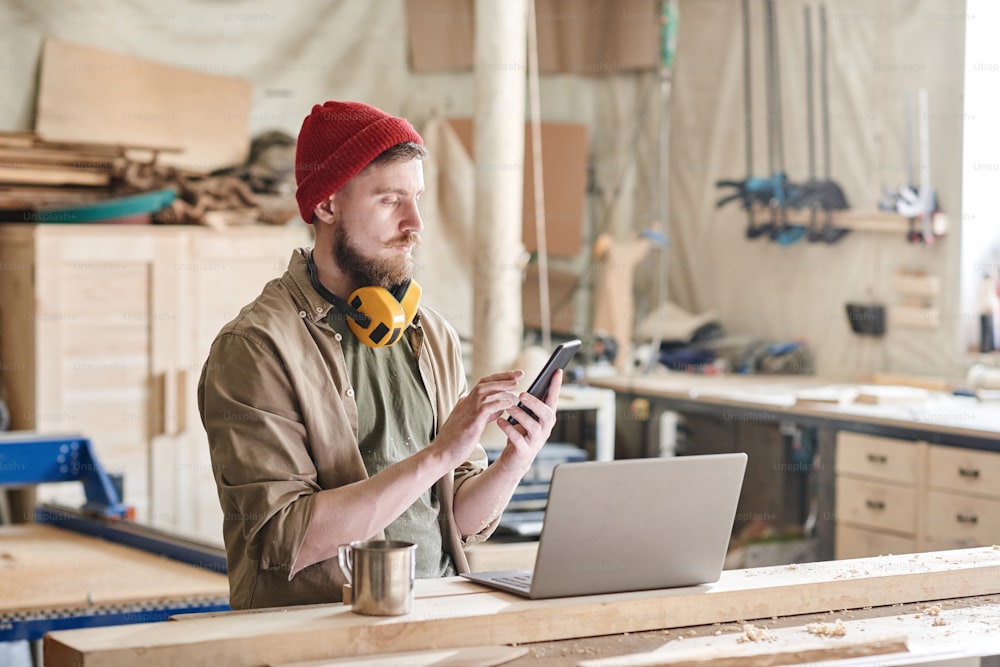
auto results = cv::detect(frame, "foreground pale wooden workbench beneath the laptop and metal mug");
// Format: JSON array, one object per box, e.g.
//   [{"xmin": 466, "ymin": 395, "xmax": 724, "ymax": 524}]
[{"xmin": 44, "ymin": 547, "xmax": 1000, "ymax": 667}]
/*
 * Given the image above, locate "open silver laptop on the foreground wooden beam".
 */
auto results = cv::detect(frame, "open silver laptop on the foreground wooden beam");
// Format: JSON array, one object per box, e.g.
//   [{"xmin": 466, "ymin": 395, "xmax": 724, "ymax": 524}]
[{"xmin": 462, "ymin": 452, "xmax": 747, "ymax": 598}]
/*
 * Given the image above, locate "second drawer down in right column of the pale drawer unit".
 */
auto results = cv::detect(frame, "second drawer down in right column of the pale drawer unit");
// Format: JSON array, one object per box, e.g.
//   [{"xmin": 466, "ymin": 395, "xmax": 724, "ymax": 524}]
[{"xmin": 926, "ymin": 491, "xmax": 1000, "ymax": 547}]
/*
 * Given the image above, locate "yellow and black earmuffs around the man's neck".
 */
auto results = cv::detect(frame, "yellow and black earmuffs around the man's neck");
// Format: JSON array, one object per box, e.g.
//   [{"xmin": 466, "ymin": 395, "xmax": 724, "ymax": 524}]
[{"xmin": 308, "ymin": 258, "xmax": 421, "ymax": 347}]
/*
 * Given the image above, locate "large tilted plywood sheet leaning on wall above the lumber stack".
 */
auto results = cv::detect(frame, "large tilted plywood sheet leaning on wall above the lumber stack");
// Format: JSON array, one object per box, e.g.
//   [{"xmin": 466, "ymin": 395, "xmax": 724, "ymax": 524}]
[{"xmin": 35, "ymin": 39, "xmax": 252, "ymax": 172}]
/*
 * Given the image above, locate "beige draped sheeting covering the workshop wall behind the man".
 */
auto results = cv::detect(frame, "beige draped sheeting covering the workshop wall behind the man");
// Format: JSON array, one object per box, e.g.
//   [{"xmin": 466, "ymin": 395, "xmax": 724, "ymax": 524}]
[{"xmin": 0, "ymin": 0, "xmax": 967, "ymax": 377}]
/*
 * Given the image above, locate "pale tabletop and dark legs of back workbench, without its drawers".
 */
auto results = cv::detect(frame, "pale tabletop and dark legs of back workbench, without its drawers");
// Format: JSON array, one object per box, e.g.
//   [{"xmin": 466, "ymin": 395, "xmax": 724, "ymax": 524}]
[{"xmin": 589, "ymin": 371, "xmax": 1000, "ymax": 560}]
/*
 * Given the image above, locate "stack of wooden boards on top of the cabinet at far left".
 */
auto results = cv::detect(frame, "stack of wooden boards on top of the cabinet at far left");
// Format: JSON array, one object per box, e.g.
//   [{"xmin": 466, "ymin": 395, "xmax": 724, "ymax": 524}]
[{"xmin": 0, "ymin": 132, "xmax": 182, "ymax": 211}]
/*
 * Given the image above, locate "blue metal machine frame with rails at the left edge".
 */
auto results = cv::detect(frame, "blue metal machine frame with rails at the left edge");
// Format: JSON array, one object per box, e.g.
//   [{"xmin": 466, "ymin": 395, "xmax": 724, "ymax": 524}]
[{"xmin": 0, "ymin": 431, "xmax": 230, "ymax": 642}]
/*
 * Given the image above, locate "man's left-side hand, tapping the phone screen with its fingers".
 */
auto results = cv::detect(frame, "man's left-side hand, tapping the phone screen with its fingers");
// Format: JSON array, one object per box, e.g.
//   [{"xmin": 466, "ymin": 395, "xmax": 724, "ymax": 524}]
[{"xmin": 431, "ymin": 371, "xmax": 524, "ymax": 467}]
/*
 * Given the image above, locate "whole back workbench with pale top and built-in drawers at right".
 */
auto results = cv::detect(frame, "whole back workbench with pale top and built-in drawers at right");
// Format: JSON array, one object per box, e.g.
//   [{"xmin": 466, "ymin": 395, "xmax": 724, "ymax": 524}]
[{"xmin": 591, "ymin": 371, "xmax": 1000, "ymax": 560}]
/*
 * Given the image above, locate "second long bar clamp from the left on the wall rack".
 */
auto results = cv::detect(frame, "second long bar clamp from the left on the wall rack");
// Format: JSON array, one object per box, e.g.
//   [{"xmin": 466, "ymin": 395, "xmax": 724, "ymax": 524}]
[{"xmin": 764, "ymin": 0, "xmax": 805, "ymax": 245}]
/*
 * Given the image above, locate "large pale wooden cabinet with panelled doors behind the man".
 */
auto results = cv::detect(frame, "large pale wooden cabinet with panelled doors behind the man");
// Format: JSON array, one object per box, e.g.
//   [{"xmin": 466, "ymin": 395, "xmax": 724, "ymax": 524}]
[{"xmin": 0, "ymin": 224, "xmax": 311, "ymax": 542}]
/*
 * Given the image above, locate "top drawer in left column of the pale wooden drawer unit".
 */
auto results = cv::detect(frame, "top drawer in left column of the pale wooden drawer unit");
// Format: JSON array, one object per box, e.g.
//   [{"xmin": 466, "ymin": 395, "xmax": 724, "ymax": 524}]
[{"xmin": 837, "ymin": 431, "xmax": 926, "ymax": 484}]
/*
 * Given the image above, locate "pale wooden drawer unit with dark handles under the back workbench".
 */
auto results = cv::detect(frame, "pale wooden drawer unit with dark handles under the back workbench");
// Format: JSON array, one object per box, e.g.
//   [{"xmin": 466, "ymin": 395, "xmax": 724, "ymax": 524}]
[{"xmin": 835, "ymin": 432, "xmax": 1000, "ymax": 558}]
